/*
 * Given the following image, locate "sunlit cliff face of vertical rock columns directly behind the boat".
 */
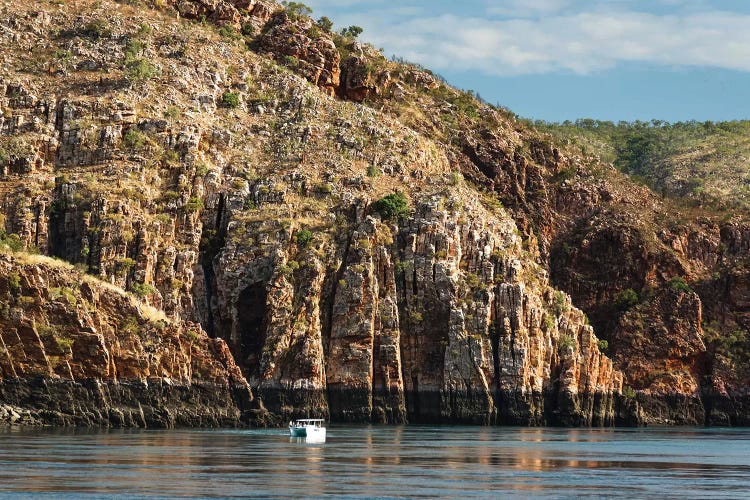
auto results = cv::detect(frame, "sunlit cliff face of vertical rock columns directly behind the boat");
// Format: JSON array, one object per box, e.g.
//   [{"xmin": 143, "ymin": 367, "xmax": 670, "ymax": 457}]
[{"xmin": 200, "ymin": 193, "xmax": 622, "ymax": 425}]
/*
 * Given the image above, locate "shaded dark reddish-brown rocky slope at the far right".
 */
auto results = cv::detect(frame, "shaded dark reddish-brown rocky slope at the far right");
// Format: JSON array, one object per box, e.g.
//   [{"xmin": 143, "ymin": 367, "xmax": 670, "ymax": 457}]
[{"xmin": 440, "ymin": 85, "xmax": 750, "ymax": 424}]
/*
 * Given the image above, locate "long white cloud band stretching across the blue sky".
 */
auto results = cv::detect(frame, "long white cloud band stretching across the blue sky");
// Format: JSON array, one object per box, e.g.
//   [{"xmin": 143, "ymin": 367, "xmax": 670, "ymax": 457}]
[{"xmin": 360, "ymin": 10, "xmax": 750, "ymax": 76}]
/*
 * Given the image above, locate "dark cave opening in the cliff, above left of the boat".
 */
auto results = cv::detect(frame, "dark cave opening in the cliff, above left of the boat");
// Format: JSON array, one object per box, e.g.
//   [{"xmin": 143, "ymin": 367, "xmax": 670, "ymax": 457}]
[{"xmin": 237, "ymin": 283, "xmax": 268, "ymax": 377}]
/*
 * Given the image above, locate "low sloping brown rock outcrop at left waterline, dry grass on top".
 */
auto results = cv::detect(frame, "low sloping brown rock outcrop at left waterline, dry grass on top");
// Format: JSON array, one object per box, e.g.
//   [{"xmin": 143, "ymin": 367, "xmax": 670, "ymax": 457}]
[{"xmin": 0, "ymin": 255, "xmax": 260, "ymax": 427}]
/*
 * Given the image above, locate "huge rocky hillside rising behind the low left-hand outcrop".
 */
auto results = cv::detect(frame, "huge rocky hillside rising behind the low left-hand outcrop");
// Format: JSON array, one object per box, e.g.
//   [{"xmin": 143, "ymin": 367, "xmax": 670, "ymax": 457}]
[{"xmin": 0, "ymin": 0, "xmax": 750, "ymax": 425}]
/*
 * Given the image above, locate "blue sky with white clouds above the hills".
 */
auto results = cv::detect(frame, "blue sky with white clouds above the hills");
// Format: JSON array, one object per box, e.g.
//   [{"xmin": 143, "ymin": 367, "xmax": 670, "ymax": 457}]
[{"xmin": 304, "ymin": 0, "xmax": 750, "ymax": 122}]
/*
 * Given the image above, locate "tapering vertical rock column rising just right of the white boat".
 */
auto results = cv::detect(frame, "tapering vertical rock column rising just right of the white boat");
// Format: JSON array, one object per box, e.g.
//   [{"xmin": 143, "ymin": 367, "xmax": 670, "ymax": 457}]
[{"xmin": 327, "ymin": 218, "xmax": 404, "ymax": 422}]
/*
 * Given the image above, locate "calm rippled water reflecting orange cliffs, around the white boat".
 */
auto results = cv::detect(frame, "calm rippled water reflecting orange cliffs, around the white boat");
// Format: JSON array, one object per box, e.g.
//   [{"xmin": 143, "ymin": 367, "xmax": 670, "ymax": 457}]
[{"xmin": 0, "ymin": 426, "xmax": 750, "ymax": 498}]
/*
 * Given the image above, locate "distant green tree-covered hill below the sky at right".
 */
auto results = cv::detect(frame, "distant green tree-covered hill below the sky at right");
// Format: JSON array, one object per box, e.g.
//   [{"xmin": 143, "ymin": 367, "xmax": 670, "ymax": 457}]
[{"xmin": 528, "ymin": 119, "xmax": 750, "ymax": 208}]
